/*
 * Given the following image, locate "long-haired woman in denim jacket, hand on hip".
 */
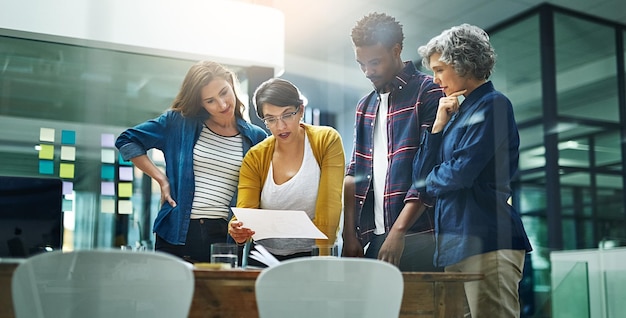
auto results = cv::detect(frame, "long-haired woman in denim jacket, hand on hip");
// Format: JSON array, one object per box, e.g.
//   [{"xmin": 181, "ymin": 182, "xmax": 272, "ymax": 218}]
[{"xmin": 115, "ymin": 61, "xmax": 267, "ymax": 262}]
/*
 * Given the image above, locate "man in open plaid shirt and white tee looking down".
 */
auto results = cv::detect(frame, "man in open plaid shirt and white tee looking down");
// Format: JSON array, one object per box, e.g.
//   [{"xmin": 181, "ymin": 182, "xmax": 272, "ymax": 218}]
[{"xmin": 342, "ymin": 13, "xmax": 443, "ymax": 271}]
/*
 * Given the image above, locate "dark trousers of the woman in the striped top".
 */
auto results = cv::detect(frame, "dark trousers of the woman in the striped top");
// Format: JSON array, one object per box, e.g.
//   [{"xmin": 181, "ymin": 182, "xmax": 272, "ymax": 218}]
[{"xmin": 154, "ymin": 219, "xmax": 228, "ymax": 263}]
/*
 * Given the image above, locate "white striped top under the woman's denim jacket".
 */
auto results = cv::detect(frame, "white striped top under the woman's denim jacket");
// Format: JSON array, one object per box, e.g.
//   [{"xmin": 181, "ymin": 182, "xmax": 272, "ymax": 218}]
[{"xmin": 191, "ymin": 126, "xmax": 243, "ymax": 219}]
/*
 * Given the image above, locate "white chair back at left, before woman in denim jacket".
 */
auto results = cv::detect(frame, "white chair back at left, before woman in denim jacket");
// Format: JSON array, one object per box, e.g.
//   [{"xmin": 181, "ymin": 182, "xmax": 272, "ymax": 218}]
[{"xmin": 12, "ymin": 250, "xmax": 194, "ymax": 318}]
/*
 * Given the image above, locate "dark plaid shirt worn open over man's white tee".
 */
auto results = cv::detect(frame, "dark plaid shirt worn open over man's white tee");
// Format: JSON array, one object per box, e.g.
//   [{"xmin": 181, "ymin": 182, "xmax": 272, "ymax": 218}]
[{"xmin": 346, "ymin": 61, "xmax": 443, "ymax": 244}]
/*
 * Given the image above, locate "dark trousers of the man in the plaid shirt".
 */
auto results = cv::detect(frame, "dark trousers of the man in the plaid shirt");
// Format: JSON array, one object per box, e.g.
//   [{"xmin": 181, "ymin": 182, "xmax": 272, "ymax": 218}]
[{"xmin": 365, "ymin": 233, "xmax": 443, "ymax": 272}]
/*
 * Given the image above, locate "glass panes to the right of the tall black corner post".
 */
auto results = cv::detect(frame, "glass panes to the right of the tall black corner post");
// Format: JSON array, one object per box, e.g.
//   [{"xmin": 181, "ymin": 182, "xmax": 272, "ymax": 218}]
[{"xmin": 554, "ymin": 8, "xmax": 624, "ymax": 243}]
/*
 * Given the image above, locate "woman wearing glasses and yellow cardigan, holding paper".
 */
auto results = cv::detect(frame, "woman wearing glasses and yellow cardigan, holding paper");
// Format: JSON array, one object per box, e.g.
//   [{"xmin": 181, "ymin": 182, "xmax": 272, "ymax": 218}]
[{"xmin": 229, "ymin": 78, "xmax": 345, "ymax": 266}]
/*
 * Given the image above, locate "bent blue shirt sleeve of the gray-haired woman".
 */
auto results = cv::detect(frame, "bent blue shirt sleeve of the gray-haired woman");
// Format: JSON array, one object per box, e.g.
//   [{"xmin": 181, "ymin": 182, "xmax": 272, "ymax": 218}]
[{"xmin": 426, "ymin": 93, "xmax": 519, "ymax": 197}]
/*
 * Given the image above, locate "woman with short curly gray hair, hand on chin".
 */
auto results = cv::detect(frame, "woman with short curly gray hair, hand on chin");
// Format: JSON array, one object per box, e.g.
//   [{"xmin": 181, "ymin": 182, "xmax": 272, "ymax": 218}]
[{"xmin": 413, "ymin": 24, "xmax": 532, "ymax": 318}]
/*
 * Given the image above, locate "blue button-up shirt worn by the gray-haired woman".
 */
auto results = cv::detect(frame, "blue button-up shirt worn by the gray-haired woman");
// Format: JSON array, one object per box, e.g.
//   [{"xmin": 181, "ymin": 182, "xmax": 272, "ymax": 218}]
[{"xmin": 414, "ymin": 82, "xmax": 531, "ymax": 266}]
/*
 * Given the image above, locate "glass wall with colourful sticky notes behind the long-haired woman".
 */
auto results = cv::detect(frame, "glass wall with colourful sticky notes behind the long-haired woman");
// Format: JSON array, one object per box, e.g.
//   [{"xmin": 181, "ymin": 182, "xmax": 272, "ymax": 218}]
[{"xmin": 0, "ymin": 33, "xmax": 247, "ymax": 250}]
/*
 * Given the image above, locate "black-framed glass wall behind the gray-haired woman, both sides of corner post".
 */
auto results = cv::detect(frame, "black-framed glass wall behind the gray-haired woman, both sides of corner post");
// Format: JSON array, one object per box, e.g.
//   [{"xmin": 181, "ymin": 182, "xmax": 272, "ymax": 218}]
[{"xmin": 488, "ymin": 5, "xmax": 626, "ymax": 313}]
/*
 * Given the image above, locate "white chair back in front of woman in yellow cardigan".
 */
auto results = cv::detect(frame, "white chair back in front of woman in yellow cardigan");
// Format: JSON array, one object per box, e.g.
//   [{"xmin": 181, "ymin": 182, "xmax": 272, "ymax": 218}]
[{"xmin": 255, "ymin": 256, "xmax": 404, "ymax": 318}]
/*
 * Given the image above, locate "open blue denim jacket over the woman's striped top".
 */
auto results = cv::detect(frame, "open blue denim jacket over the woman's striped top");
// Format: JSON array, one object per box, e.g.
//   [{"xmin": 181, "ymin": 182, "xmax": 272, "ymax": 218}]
[{"xmin": 115, "ymin": 110, "xmax": 267, "ymax": 245}]
